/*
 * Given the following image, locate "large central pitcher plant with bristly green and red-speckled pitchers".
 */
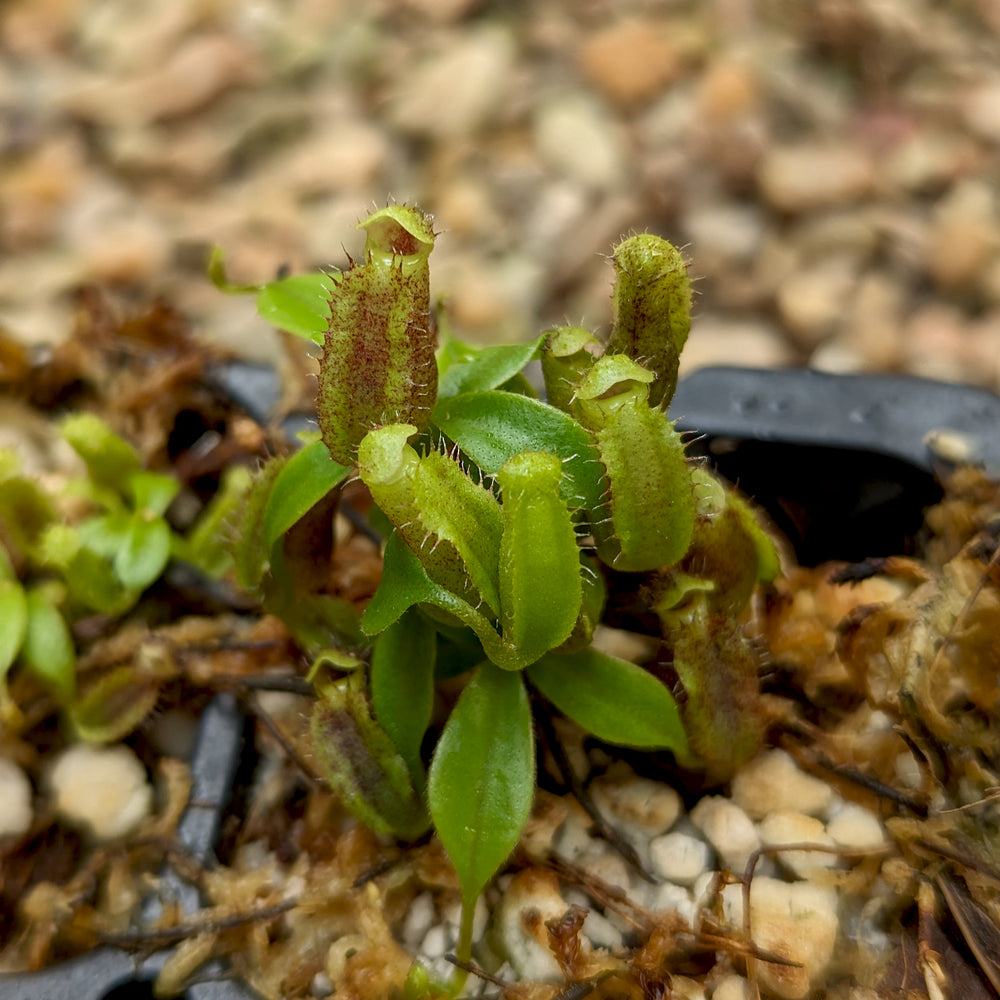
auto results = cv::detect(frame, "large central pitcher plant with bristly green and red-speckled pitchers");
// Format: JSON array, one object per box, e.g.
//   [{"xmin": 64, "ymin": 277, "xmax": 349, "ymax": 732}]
[{"xmin": 214, "ymin": 205, "xmax": 778, "ymax": 985}]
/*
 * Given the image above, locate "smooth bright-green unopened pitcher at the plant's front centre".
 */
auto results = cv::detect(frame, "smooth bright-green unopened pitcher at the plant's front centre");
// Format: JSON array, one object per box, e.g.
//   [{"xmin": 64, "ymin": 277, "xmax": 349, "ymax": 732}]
[{"xmin": 497, "ymin": 452, "xmax": 582, "ymax": 662}]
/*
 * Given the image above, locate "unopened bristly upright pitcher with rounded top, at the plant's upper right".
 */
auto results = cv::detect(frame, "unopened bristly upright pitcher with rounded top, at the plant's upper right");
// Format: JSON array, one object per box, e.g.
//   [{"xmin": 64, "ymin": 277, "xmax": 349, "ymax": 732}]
[{"xmin": 606, "ymin": 233, "xmax": 691, "ymax": 409}]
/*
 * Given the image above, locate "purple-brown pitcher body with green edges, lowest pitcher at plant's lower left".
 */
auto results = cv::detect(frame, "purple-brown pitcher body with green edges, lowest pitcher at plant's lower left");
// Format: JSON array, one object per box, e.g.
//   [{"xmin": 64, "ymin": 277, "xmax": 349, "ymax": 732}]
[{"xmin": 311, "ymin": 679, "xmax": 428, "ymax": 840}]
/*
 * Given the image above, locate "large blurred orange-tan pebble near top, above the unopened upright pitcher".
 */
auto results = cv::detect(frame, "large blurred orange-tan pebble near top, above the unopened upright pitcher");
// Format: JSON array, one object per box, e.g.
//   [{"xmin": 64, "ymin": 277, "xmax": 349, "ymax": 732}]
[{"xmin": 579, "ymin": 19, "xmax": 680, "ymax": 104}]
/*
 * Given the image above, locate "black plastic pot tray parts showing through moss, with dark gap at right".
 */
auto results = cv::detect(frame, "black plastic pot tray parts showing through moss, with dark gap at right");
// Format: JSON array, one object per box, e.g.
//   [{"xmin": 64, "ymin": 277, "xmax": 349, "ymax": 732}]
[{"xmin": 0, "ymin": 362, "xmax": 1000, "ymax": 1000}]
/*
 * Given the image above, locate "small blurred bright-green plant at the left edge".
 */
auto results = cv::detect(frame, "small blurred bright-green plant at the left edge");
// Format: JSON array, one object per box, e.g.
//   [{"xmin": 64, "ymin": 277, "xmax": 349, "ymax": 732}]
[{"xmin": 0, "ymin": 414, "xmax": 249, "ymax": 743}]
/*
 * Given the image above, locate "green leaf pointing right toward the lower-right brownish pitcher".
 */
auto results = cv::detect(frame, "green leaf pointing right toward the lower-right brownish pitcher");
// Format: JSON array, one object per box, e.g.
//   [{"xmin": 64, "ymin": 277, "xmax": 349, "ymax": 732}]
[{"xmin": 527, "ymin": 649, "xmax": 687, "ymax": 757}]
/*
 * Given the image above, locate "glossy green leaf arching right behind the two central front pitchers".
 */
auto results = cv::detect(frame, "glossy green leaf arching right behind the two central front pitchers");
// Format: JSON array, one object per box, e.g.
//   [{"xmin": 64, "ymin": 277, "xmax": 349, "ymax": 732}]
[{"xmin": 434, "ymin": 390, "xmax": 604, "ymax": 510}]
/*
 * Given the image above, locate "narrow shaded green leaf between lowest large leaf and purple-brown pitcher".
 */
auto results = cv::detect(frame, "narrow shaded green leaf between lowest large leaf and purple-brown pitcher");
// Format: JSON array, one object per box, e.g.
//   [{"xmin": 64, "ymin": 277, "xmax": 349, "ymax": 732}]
[{"xmin": 371, "ymin": 608, "xmax": 437, "ymax": 788}]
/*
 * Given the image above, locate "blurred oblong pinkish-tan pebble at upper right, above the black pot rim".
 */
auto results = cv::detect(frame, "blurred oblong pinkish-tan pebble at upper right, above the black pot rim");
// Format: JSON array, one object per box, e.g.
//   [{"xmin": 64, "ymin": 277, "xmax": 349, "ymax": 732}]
[{"xmin": 758, "ymin": 142, "xmax": 874, "ymax": 212}]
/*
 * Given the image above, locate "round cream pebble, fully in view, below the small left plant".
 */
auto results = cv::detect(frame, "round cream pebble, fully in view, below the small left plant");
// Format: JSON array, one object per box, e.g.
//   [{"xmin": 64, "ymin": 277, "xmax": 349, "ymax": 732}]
[{"xmin": 48, "ymin": 743, "xmax": 153, "ymax": 840}]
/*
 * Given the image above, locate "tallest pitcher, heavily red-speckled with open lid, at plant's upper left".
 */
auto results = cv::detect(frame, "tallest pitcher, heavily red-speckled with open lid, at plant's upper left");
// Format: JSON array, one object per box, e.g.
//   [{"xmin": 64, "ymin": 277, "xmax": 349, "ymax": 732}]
[{"xmin": 317, "ymin": 205, "xmax": 438, "ymax": 465}]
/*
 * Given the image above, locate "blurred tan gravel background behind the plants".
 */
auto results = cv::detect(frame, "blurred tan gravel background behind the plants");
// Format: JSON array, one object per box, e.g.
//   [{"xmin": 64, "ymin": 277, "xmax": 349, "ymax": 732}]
[{"xmin": 0, "ymin": 0, "xmax": 1000, "ymax": 388}]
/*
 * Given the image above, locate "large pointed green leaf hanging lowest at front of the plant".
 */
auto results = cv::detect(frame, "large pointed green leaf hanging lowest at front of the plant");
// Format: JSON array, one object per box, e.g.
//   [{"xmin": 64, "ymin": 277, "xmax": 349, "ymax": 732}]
[{"xmin": 428, "ymin": 663, "xmax": 535, "ymax": 910}]
